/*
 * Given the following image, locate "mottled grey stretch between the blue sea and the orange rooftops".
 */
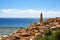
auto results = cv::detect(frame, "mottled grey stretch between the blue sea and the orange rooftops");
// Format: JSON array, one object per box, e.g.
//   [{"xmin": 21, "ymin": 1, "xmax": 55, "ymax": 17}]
[{"xmin": 0, "ymin": 27, "xmax": 19, "ymax": 36}]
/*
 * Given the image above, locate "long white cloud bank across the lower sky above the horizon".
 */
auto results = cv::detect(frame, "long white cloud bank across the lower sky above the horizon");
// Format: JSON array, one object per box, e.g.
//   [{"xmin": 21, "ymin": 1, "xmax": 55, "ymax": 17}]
[{"xmin": 0, "ymin": 8, "xmax": 60, "ymax": 18}]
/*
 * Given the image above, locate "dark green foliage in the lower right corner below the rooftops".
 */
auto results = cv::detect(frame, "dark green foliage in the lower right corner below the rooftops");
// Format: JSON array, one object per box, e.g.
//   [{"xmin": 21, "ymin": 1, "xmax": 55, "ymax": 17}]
[{"xmin": 37, "ymin": 28, "xmax": 60, "ymax": 40}]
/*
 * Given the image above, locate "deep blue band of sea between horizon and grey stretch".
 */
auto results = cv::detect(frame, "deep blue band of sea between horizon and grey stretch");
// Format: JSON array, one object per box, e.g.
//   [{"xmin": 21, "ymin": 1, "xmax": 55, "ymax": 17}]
[{"xmin": 0, "ymin": 18, "xmax": 47, "ymax": 27}]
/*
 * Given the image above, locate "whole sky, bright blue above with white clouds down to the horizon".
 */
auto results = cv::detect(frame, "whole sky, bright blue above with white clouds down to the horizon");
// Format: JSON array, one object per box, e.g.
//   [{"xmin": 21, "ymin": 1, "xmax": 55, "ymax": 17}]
[{"xmin": 0, "ymin": 0, "xmax": 60, "ymax": 18}]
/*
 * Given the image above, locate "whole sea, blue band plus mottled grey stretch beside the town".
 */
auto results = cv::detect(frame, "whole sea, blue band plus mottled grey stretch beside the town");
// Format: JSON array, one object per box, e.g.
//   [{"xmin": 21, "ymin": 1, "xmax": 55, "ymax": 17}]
[{"xmin": 0, "ymin": 18, "xmax": 47, "ymax": 36}]
